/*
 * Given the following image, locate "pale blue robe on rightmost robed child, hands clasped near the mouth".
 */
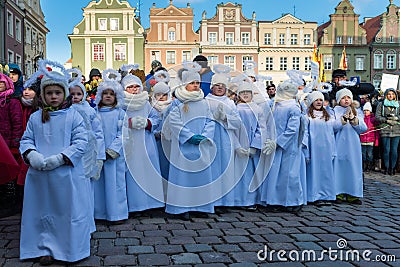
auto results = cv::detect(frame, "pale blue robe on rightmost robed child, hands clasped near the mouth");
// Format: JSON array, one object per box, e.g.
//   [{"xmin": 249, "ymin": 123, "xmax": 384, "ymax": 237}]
[{"xmin": 333, "ymin": 106, "xmax": 368, "ymax": 197}]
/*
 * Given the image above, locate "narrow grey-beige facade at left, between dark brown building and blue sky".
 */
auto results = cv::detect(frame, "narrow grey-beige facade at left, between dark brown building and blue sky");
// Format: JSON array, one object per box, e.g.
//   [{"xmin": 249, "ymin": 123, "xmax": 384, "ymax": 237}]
[{"xmin": 23, "ymin": 0, "xmax": 49, "ymax": 77}]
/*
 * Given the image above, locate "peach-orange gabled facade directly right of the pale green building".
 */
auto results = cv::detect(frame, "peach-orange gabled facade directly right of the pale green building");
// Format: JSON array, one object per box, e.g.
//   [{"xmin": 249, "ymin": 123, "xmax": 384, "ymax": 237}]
[{"xmin": 145, "ymin": 0, "xmax": 200, "ymax": 73}]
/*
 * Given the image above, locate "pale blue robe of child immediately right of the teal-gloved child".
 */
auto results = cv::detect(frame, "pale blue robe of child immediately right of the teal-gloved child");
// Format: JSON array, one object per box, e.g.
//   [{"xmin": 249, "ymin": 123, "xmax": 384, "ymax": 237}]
[{"xmin": 205, "ymin": 94, "xmax": 242, "ymax": 206}]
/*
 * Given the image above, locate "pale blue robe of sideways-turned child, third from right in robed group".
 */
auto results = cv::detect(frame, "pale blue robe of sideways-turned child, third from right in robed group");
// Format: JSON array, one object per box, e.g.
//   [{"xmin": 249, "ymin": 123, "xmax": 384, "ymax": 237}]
[{"xmin": 261, "ymin": 99, "xmax": 305, "ymax": 207}]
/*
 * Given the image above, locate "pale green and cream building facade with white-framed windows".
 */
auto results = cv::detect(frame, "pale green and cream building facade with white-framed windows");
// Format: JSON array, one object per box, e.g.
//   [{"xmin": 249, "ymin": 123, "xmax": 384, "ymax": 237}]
[{"xmin": 68, "ymin": 0, "xmax": 144, "ymax": 75}]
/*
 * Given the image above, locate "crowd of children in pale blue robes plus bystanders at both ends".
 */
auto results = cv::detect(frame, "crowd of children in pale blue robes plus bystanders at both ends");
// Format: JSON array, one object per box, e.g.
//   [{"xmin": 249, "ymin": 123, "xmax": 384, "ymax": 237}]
[{"xmin": 0, "ymin": 57, "xmax": 400, "ymax": 265}]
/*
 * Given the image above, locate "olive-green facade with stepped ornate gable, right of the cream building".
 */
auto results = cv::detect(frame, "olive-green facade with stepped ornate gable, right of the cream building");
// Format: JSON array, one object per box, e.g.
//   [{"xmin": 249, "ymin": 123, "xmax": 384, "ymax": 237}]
[{"xmin": 318, "ymin": 0, "xmax": 371, "ymax": 82}]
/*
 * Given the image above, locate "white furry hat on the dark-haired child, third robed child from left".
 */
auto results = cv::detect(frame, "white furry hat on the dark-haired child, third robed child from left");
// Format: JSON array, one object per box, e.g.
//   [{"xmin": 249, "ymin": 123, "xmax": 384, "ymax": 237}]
[{"xmin": 95, "ymin": 69, "xmax": 125, "ymax": 107}]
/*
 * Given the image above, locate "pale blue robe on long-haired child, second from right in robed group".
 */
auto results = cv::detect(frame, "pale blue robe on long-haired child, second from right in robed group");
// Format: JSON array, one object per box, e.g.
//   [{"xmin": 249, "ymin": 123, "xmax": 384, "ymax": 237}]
[{"xmin": 307, "ymin": 111, "xmax": 337, "ymax": 202}]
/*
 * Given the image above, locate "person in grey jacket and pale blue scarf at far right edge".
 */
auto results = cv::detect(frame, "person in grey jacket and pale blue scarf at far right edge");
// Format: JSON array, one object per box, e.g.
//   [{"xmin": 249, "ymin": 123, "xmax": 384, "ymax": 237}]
[{"xmin": 375, "ymin": 88, "xmax": 400, "ymax": 175}]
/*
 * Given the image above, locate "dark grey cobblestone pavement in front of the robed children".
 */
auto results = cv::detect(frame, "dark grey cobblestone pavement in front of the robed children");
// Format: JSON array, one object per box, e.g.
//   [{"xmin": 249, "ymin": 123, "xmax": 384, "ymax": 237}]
[{"xmin": 0, "ymin": 172, "xmax": 400, "ymax": 267}]
